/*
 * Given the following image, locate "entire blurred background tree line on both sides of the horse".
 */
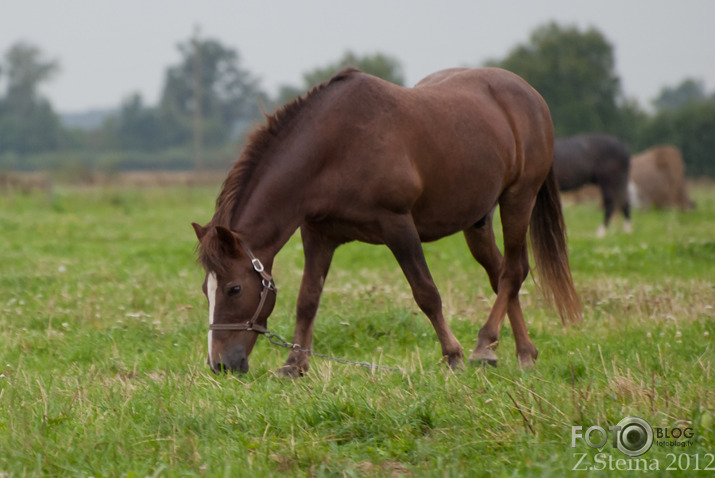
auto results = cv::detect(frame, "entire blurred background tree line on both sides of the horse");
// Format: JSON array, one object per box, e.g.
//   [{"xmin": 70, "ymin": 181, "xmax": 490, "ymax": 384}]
[{"xmin": 0, "ymin": 23, "xmax": 715, "ymax": 176}]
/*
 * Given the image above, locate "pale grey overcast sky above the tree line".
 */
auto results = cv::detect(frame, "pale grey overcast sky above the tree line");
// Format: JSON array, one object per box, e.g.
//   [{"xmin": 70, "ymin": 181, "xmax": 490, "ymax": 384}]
[{"xmin": 0, "ymin": 0, "xmax": 715, "ymax": 113}]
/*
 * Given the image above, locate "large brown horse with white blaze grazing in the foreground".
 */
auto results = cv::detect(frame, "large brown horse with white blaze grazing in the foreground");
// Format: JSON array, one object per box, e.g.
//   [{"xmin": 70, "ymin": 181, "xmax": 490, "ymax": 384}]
[{"xmin": 193, "ymin": 69, "xmax": 580, "ymax": 376}]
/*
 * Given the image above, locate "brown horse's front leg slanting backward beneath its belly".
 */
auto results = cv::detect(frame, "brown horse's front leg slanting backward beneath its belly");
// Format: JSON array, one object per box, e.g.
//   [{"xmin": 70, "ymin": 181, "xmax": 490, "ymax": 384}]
[{"xmin": 381, "ymin": 215, "xmax": 464, "ymax": 368}]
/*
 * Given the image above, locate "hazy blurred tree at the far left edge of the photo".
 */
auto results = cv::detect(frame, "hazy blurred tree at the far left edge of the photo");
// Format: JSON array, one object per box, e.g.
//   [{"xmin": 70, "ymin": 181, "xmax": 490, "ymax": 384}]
[{"xmin": 0, "ymin": 42, "xmax": 62, "ymax": 154}]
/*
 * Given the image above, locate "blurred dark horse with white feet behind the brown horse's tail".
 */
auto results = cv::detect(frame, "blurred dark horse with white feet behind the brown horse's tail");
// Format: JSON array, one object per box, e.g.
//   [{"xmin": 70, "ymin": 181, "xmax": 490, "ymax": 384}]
[{"xmin": 554, "ymin": 134, "xmax": 631, "ymax": 237}]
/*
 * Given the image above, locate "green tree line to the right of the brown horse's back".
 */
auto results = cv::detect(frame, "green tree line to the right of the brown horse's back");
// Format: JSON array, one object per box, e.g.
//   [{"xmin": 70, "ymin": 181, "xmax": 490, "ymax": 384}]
[{"xmin": 488, "ymin": 23, "xmax": 715, "ymax": 177}]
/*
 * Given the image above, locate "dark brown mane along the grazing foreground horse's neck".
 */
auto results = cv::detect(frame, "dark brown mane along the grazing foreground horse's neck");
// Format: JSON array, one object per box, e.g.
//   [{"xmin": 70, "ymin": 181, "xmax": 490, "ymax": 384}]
[{"xmin": 211, "ymin": 68, "xmax": 359, "ymax": 227}]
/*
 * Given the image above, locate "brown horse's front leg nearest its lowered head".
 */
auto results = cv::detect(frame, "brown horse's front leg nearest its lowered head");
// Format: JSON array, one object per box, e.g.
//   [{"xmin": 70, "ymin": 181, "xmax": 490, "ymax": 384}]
[{"xmin": 278, "ymin": 225, "xmax": 338, "ymax": 378}]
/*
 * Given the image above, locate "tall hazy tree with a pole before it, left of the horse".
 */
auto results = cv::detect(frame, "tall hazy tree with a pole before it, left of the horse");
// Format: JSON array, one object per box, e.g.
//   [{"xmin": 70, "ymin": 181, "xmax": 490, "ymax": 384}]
[{"xmin": 159, "ymin": 38, "xmax": 263, "ymax": 145}]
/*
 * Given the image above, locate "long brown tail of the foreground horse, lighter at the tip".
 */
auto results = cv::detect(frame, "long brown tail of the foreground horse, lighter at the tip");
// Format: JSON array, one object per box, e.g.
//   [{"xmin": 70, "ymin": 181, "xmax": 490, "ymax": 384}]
[{"xmin": 530, "ymin": 166, "xmax": 582, "ymax": 324}]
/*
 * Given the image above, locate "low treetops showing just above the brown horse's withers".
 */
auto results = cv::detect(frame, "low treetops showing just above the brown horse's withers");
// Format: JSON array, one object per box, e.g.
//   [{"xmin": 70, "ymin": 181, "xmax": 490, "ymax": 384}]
[{"xmin": 278, "ymin": 51, "xmax": 405, "ymax": 104}]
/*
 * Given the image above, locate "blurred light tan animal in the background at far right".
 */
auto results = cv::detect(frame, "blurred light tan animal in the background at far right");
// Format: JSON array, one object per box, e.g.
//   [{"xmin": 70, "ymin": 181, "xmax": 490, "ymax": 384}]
[{"xmin": 628, "ymin": 144, "xmax": 695, "ymax": 211}]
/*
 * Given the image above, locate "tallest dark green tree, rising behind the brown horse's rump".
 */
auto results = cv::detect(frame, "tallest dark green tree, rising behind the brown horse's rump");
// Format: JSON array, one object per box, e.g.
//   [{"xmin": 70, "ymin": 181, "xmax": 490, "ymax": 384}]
[{"xmin": 489, "ymin": 23, "xmax": 622, "ymax": 136}]
